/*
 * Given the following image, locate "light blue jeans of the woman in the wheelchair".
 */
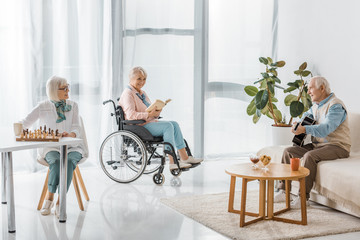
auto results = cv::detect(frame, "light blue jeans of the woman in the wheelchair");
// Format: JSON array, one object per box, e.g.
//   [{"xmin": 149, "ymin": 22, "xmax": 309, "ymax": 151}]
[{"xmin": 144, "ymin": 121, "xmax": 185, "ymax": 150}]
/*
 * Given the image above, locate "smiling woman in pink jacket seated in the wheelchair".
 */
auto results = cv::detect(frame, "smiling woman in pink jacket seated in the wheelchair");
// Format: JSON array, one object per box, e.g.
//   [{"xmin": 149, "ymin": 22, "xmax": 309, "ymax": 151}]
[{"xmin": 119, "ymin": 67, "xmax": 202, "ymax": 170}]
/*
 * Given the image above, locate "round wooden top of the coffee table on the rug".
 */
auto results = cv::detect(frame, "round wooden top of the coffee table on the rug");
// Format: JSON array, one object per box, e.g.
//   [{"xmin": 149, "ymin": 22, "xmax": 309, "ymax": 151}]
[{"xmin": 225, "ymin": 162, "xmax": 310, "ymax": 180}]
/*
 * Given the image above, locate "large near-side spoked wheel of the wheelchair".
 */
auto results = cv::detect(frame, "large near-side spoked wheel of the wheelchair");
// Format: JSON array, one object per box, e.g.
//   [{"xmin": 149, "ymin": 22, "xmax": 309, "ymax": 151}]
[{"xmin": 99, "ymin": 131, "xmax": 147, "ymax": 183}]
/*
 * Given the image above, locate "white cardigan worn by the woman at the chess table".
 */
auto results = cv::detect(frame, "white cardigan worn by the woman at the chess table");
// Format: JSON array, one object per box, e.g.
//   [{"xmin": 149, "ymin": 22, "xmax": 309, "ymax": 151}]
[{"xmin": 21, "ymin": 100, "xmax": 84, "ymax": 158}]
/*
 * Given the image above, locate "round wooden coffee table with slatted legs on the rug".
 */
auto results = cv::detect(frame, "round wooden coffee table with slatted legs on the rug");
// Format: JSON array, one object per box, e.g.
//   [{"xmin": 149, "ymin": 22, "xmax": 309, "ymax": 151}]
[{"xmin": 225, "ymin": 163, "xmax": 310, "ymax": 227}]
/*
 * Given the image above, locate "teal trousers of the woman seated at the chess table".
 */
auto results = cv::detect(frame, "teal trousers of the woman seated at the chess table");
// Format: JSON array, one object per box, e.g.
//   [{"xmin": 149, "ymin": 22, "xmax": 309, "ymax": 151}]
[{"xmin": 45, "ymin": 151, "xmax": 82, "ymax": 193}]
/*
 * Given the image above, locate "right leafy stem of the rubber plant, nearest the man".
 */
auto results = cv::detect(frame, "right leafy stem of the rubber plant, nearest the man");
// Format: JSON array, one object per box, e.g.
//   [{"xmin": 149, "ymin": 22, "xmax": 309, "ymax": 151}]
[{"xmin": 284, "ymin": 62, "xmax": 312, "ymax": 125}]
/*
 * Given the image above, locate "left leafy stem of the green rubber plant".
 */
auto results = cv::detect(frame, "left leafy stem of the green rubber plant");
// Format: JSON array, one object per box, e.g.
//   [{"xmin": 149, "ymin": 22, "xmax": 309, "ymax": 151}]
[{"xmin": 244, "ymin": 57, "xmax": 286, "ymax": 126}]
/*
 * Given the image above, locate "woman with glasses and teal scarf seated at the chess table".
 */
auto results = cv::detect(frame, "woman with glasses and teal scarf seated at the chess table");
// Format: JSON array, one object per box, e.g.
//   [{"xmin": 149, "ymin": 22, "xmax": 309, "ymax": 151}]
[{"xmin": 21, "ymin": 76, "xmax": 83, "ymax": 217}]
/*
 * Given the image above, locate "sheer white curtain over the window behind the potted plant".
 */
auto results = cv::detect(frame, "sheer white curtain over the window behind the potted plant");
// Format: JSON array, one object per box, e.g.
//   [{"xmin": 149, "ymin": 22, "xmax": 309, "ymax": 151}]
[{"xmin": 205, "ymin": 0, "xmax": 274, "ymax": 158}]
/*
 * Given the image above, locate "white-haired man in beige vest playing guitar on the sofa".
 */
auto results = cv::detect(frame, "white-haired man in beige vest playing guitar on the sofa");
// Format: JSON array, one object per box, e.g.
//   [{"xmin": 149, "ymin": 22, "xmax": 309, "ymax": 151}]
[{"xmin": 274, "ymin": 76, "xmax": 351, "ymax": 208}]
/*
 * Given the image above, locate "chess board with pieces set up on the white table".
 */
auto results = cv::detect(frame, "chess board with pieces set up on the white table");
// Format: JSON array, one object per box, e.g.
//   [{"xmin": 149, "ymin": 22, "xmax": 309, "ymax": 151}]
[{"xmin": 16, "ymin": 126, "xmax": 61, "ymax": 142}]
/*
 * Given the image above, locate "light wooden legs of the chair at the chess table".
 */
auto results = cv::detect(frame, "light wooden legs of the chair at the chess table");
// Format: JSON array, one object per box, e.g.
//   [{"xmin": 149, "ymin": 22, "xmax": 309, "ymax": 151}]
[{"xmin": 37, "ymin": 166, "xmax": 90, "ymax": 211}]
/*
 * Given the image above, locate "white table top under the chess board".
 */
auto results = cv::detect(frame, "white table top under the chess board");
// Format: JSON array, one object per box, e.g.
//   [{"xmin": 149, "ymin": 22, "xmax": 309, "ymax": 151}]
[{"xmin": 0, "ymin": 129, "xmax": 83, "ymax": 152}]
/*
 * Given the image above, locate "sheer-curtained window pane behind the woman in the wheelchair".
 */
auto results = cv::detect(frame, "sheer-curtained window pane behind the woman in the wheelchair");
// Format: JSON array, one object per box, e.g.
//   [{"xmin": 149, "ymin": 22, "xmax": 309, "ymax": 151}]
[{"xmin": 122, "ymin": 0, "xmax": 194, "ymax": 149}]
